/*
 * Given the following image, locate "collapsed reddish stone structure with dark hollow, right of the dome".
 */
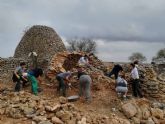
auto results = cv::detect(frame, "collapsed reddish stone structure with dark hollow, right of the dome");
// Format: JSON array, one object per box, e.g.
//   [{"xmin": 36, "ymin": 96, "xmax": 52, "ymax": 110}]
[{"xmin": 47, "ymin": 52, "xmax": 111, "ymax": 86}]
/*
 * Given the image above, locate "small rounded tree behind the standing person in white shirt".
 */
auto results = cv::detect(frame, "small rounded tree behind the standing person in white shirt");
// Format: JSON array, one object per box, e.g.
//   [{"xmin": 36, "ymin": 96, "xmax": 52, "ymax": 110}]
[{"xmin": 128, "ymin": 52, "xmax": 147, "ymax": 62}]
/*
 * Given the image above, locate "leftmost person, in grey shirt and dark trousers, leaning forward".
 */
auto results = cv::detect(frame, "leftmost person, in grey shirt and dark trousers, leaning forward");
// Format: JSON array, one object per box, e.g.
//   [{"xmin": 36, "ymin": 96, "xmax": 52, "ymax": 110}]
[{"xmin": 12, "ymin": 62, "xmax": 28, "ymax": 92}]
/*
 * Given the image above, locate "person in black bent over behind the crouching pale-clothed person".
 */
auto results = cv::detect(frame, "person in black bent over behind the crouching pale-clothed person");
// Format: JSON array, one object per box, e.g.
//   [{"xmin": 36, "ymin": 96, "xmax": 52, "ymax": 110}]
[{"xmin": 108, "ymin": 64, "xmax": 123, "ymax": 80}]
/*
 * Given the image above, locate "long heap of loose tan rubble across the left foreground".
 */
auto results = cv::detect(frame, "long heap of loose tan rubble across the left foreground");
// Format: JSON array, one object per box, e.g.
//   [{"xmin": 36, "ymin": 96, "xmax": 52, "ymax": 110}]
[{"xmin": 0, "ymin": 89, "xmax": 130, "ymax": 124}]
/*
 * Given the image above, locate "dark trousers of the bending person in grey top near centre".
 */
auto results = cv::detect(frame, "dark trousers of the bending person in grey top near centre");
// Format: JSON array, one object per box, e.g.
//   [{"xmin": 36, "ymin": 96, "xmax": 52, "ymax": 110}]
[{"xmin": 56, "ymin": 76, "xmax": 66, "ymax": 96}]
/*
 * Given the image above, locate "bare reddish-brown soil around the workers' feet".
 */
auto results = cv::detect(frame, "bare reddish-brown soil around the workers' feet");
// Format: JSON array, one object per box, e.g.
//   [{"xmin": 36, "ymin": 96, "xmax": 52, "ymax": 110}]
[{"xmin": 0, "ymin": 78, "xmax": 125, "ymax": 124}]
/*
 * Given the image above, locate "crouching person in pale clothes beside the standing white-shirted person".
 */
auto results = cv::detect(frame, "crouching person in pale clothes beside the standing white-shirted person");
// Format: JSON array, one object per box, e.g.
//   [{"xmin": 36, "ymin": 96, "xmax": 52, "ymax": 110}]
[{"xmin": 116, "ymin": 74, "xmax": 128, "ymax": 99}]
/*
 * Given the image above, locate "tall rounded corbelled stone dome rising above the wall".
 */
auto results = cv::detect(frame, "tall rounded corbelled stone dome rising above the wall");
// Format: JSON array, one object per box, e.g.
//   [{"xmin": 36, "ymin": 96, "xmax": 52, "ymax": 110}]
[{"xmin": 14, "ymin": 25, "xmax": 66, "ymax": 59}]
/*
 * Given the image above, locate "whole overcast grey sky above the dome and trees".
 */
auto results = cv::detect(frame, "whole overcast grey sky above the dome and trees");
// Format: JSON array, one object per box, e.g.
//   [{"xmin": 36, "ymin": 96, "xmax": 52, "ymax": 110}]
[{"xmin": 0, "ymin": 0, "xmax": 165, "ymax": 62}]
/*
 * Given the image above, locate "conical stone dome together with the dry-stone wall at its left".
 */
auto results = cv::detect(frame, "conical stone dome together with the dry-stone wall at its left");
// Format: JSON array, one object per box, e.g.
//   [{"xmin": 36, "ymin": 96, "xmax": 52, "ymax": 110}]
[{"xmin": 0, "ymin": 25, "xmax": 66, "ymax": 82}]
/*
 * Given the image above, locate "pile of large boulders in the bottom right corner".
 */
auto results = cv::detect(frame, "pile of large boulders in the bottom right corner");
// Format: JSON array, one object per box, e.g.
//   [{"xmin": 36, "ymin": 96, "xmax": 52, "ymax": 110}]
[{"xmin": 121, "ymin": 99, "xmax": 165, "ymax": 124}]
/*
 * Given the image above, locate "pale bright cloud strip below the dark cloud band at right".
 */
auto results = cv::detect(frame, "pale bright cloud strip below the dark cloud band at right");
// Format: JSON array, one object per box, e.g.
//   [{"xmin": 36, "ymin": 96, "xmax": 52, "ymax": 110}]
[{"xmin": 96, "ymin": 40, "xmax": 165, "ymax": 62}]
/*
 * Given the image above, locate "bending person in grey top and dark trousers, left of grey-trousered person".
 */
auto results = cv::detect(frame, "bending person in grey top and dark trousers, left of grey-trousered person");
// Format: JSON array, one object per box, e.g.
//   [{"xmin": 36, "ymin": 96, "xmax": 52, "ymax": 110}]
[{"xmin": 56, "ymin": 71, "xmax": 72, "ymax": 97}]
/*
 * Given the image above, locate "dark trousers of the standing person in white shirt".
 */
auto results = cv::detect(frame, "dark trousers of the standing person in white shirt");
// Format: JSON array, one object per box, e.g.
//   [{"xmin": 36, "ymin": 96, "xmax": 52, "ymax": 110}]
[{"xmin": 132, "ymin": 79, "xmax": 143, "ymax": 98}]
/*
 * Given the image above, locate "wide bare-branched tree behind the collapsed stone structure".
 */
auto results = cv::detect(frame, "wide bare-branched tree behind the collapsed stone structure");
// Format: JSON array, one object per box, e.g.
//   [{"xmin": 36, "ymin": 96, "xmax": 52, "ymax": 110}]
[{"xmin": 67, "ymin": 38, "xmax": 97, "ymax": 53}]
